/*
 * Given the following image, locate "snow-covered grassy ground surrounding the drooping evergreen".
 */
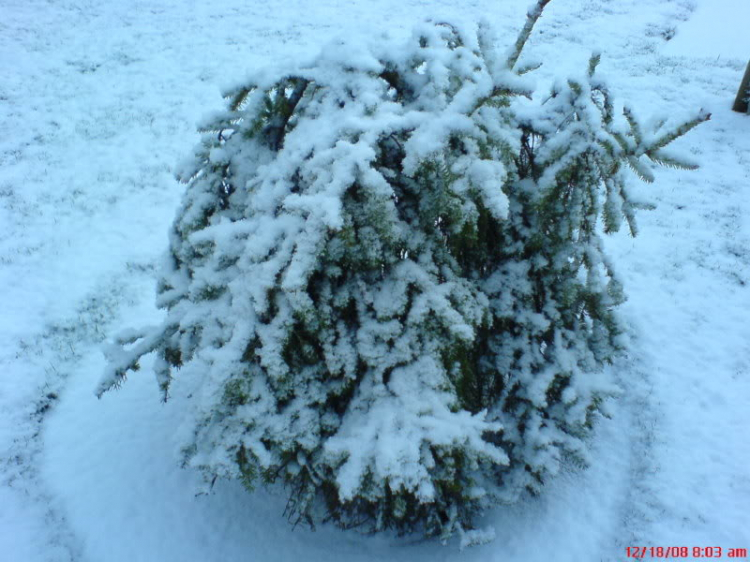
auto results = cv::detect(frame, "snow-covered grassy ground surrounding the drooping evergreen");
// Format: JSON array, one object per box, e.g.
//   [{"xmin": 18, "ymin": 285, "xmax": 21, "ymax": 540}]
[{"xmin": 0, "ymin": 0, "xmax": 750, "ymax": 562}]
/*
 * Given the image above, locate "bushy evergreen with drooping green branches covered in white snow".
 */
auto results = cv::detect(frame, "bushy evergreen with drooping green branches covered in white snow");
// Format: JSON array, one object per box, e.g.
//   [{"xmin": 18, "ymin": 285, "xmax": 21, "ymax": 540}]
[{"xmin": 98, "ymin": 0, "xmax": 708, "ymax": 537}]
